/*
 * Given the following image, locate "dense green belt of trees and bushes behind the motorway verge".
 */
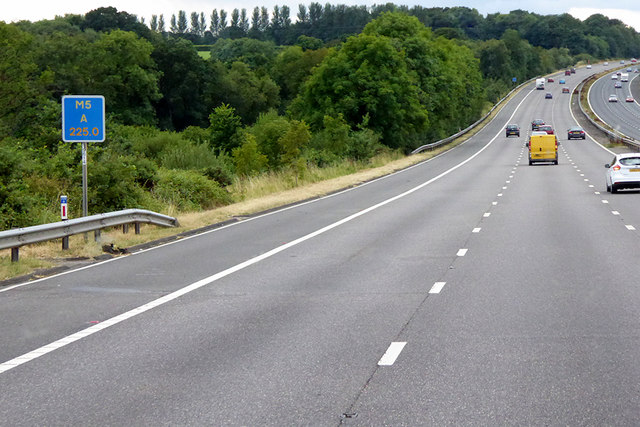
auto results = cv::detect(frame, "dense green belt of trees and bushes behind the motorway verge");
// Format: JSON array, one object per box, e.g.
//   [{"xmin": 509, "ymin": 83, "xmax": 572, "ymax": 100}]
[{"xmin": 0, "ymin": 3, "xmax": 640, "ymax": 229}]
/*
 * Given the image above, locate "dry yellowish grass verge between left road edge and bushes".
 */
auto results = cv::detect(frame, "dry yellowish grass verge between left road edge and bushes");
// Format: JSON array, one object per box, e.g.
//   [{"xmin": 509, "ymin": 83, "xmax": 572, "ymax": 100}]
[{"xmin": 0, "ymin": 90, "xmax": 516, "ymax": 280}]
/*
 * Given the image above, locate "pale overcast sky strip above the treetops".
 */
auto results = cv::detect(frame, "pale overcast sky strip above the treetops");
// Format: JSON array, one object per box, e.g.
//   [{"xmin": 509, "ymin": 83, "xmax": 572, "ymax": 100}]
[{"xmin": 0, "ymin": 0, "xmax": 640, "ymax": 32}]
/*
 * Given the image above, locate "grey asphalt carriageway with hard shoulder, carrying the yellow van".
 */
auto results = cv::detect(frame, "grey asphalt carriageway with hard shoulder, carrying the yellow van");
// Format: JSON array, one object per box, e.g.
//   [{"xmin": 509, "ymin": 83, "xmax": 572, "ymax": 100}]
[{"xmin": 0, "ymin": 68, "xmax": 640, "ymax": 426}]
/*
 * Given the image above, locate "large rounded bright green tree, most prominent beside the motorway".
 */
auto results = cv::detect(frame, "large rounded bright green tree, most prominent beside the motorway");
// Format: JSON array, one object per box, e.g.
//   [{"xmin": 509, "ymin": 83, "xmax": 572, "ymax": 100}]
[{"xmin": 292, "ymin": 34, "xmax": 427, "ymax": 149}]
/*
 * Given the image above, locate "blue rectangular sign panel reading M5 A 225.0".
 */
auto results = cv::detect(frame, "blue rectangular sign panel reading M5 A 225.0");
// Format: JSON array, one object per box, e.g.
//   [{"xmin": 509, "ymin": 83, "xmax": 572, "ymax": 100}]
[{"xmin": 62, "ymin": 95, "xmax": 105, "ymax": 142}]
